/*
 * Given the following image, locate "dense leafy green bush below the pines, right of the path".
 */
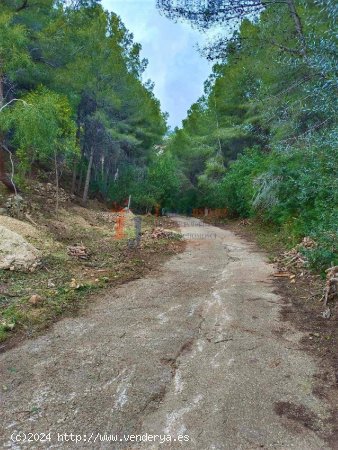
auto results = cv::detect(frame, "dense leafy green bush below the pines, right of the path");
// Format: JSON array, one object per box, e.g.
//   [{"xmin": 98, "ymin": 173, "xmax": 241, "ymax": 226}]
[{"xmin": 220, "ymin": 140, "xmax": 338, "ymax": 271}]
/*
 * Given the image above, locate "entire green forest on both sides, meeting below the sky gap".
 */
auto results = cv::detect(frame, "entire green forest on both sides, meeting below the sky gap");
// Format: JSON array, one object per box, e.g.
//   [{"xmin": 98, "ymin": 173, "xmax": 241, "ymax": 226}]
[{"xmin": 0, "ymin": 0, "xmax": 338, "ymax": 269}]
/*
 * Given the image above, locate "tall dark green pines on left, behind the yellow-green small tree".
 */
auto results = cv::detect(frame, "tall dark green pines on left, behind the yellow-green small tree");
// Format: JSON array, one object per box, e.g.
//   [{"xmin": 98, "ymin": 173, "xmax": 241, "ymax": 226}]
[{"xmin": 0, "ymin": 0, "xmax": 166, "ymax": 207}]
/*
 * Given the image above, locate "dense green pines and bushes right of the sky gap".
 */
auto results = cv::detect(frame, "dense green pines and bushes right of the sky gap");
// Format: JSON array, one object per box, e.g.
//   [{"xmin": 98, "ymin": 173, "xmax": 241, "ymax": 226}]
[{"xmin": 159, "ymin": 0, "xmax": 338, "ymax": 268}]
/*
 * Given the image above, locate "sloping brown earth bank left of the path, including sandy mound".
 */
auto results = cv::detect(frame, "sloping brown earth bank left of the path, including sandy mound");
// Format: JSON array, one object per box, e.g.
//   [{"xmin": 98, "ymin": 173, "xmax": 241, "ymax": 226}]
[{"xmin": 0, "ymin": 203, "xmax": 184, "ymax": 352}]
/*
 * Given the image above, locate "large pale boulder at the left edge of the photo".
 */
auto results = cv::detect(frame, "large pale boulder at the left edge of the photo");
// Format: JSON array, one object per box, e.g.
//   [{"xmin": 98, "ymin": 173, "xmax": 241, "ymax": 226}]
[{"xmin": 0, "ymin": 225, "xmax": 40, "ymax": 270}]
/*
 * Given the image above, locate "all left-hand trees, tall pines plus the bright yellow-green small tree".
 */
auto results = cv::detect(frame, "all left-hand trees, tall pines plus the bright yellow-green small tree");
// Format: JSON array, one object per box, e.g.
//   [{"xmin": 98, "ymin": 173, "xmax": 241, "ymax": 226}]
[{"xmin": 0, "ymin": 0, "xmax": 166, "ymax": 208}]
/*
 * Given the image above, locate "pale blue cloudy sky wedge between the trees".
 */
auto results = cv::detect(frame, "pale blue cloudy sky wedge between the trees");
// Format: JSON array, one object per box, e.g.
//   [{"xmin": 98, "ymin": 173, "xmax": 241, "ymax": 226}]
[{"xmin": 102, "ymin": 0, "xmax": 211, "ymax": 128}]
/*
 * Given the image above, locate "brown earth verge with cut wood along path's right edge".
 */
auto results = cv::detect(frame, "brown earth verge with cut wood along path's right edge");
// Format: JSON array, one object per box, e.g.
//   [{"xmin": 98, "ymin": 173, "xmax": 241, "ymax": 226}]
[{"xmin": 221, "ymin": 221, "xmax": 338, "ymax": 449}]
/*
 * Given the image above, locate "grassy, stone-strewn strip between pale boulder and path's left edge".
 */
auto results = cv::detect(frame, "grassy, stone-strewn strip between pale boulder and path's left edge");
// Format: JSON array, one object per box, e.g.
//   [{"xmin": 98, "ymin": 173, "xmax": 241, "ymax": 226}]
[{"xmin": 0, "ymin": 211, "xmax": 183, "ymax": 341}]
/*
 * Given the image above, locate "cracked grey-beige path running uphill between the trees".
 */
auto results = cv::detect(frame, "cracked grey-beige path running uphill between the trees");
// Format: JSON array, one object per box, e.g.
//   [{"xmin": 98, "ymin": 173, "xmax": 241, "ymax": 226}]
[{"xmin": 0, "ymin": 218, "xmax": 329, "ymax": 450}]
